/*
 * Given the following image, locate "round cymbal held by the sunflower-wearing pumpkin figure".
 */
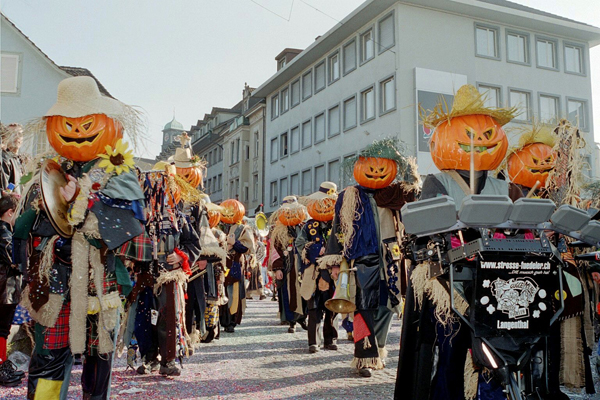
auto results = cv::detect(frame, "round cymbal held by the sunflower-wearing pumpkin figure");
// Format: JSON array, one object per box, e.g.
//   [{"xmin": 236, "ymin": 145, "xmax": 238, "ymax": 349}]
[{"xmin": 40, "ymin": 160, "xmax": 74, "ymax": 238}]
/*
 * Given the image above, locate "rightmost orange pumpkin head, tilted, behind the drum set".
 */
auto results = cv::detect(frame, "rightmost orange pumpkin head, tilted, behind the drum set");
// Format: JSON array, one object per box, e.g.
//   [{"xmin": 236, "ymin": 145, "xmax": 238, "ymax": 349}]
[{"xmin": 506, "ymin": 143, "xmax": 556, "ymax": 188}]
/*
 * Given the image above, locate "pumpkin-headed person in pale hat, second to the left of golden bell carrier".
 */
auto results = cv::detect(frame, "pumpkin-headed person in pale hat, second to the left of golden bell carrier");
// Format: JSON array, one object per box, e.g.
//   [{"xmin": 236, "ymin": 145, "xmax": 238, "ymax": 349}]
[{"xmin": 270, "ymin": 196, "xmax": 308, "ymax": 333}]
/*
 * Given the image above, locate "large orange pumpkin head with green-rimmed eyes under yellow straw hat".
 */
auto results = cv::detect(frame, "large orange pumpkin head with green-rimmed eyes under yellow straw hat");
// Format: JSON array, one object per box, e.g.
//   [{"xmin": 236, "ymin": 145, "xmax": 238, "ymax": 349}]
[{"xmin": 429, "ymin": 114, "xmax": 508, "ymax": 171}]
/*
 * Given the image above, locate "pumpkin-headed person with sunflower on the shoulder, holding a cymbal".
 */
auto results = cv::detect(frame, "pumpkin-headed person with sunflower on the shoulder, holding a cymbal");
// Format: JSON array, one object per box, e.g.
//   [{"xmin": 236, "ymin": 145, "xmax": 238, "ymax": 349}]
[{"xmin": 13, "ymin": 76, "xmax": 144, "ymax": 399}]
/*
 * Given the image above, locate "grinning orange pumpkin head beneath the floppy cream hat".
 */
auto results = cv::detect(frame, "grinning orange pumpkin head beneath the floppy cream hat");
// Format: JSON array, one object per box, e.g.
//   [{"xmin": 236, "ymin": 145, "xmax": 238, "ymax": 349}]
[{"xmin": 46, "ymin": 114, "xmax": 123, "ymax": 161}]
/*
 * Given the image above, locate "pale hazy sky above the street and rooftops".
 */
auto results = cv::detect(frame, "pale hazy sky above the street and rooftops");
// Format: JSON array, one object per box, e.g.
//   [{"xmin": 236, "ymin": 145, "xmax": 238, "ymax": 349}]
[{"xmin": 0, "ymin": 0, "xmax": 600, "ymax": 158}]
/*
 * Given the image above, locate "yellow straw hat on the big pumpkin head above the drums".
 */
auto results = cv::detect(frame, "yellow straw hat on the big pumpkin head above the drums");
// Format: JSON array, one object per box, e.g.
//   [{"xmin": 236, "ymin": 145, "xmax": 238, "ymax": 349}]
[{"xmin": 421, "ymin": 85, "xmax": 519, "ymax": 128}]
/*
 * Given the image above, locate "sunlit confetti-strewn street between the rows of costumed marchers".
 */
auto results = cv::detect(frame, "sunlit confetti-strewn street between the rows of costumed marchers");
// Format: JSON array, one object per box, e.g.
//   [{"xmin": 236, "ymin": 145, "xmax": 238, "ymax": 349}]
[{"xmin": 1, "ymin": 299, "xmax": 400, "ymax": 400}]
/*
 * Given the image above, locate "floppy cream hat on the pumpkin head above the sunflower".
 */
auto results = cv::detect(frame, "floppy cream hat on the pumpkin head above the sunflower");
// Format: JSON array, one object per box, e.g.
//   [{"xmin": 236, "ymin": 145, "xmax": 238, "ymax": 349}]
[{"xmin": 45, "ymin": 76, "xmax": 126, "ymax": 118}]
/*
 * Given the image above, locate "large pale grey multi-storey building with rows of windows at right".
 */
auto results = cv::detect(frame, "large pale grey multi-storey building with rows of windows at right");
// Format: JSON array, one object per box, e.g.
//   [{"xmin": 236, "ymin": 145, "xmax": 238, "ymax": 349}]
[{"xmin": 253, "ymin": 0, "xmax": 600, "ymax": 211}]
